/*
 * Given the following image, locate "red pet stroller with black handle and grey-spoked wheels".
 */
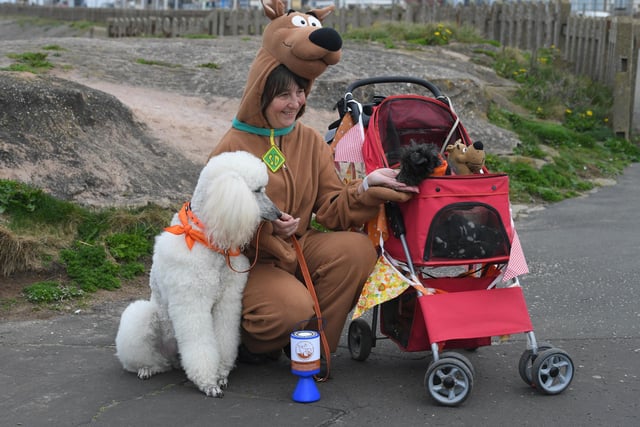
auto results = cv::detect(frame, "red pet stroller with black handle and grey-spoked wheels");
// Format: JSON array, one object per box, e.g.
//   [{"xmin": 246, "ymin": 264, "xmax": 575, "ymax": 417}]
[{"xmin": 327, "ymin": 76, "xmax": 574, "ymax": 406}]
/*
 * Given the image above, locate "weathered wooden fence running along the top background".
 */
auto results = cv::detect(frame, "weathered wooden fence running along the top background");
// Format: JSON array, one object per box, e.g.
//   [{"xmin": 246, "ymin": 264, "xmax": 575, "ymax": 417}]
[{"xmin": 0, "ymin": 0, "xmax": 640, "ymax": 138}]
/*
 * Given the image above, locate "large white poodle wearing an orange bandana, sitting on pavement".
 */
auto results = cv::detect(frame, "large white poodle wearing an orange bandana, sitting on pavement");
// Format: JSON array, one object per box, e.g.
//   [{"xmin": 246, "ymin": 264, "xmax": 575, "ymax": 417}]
[{"xmin": 116, "ymin": 151, "xmax": 281, "ymax": 397}]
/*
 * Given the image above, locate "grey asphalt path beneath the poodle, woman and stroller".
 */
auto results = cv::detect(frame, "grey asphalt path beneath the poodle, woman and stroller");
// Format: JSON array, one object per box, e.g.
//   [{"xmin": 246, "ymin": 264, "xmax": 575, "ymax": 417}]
[{"xmin": 0, "ymin": 165, "xmax": 640, "ymax": 426}]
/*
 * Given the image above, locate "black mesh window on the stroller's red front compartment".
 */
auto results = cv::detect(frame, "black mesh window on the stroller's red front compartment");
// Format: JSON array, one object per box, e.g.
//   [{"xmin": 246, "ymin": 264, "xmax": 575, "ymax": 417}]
[{"xmin": 424, "ymin": 202, "xmax": 510, "ymax": 261}]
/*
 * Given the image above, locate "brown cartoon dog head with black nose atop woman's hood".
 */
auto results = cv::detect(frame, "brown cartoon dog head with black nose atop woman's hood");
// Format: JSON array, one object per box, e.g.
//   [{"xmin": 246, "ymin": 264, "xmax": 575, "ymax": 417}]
[{"xmin": 261, "ymin": 0, "xmax": 342, "ymax": 81}]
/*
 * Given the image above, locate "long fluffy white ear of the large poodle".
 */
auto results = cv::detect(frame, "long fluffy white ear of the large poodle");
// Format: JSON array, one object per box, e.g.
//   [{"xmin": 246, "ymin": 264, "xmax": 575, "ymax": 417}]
[{"xmin": 200, "ymin": 172, "xmax": 260, "ymax": 249}]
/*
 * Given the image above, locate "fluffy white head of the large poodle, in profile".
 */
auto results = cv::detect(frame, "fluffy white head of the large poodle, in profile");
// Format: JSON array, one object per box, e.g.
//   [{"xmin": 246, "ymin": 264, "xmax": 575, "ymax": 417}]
[{"xmin": 191, "ymin": 151, "xmax": 282, "ymax": 249}]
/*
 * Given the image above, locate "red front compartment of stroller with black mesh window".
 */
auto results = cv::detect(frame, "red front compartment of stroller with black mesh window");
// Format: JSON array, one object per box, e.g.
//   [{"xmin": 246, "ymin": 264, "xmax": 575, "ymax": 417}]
[{"xmin": 385, "ymin": 174, "xmax": 513, "ymax": 266}]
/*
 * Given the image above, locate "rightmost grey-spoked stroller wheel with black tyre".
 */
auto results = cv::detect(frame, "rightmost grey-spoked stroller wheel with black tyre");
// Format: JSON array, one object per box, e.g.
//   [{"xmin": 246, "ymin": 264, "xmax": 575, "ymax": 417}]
[{"xmin": 531, "ymin": 348, "xmax": 574, "ymax": 394}]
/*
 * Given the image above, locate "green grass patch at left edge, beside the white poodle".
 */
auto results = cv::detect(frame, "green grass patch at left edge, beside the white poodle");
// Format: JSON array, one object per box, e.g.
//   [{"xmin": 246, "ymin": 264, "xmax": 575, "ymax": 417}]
[{"xmin": 0, "ymin": 180, "xmax": 173, "ymax": 302}]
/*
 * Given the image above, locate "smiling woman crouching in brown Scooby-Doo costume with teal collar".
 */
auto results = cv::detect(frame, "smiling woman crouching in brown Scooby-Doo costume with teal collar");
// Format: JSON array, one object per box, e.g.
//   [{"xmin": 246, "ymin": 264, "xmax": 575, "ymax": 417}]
[{"xmin": 211, "ymin": 0, "xmax": 418, "ymax": 362}]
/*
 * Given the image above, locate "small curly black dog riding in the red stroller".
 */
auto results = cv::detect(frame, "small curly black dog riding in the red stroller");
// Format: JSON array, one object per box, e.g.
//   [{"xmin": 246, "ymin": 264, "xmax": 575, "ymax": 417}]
[{"xmin": 396, "ymin": 141, "xmax": 442, "ymax": 185}]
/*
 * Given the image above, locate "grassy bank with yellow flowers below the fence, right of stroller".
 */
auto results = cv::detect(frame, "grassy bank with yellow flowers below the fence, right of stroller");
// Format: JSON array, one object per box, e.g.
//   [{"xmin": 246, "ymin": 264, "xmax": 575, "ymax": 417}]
[{"xmin": 487, "ymin": 42, "xmax": 640, "ymax": 203}]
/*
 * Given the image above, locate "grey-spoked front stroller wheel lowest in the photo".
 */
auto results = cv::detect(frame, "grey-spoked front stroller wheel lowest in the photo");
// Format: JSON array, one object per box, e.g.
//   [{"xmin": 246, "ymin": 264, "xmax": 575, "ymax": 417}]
[{"xmin": 424, "ymin": 357, "xmax": 473, "ymax": 406}]
